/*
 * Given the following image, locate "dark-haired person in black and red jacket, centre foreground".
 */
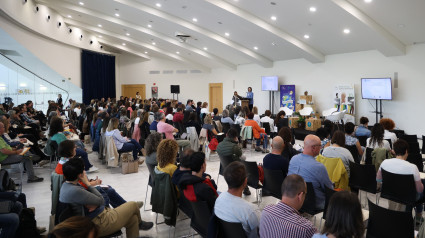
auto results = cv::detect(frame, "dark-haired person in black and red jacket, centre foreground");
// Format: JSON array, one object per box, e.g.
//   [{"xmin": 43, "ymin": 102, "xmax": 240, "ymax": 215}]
[{"xmin": 176, "ymin": 152, "xmax": 218, "ymax": 211}]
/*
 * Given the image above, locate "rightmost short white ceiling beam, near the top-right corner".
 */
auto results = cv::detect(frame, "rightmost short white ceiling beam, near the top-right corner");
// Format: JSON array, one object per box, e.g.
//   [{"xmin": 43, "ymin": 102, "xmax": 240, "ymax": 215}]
[{"xmin": 332, "ymin": 0, "xmax": 406, "ymax": 56}]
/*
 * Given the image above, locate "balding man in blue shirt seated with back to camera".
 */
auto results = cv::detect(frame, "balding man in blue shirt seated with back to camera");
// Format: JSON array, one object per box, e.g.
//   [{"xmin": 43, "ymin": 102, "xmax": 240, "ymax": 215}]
[{"xmin": 288, "ymin": 135, "xmax": 333, "ymax": 209}]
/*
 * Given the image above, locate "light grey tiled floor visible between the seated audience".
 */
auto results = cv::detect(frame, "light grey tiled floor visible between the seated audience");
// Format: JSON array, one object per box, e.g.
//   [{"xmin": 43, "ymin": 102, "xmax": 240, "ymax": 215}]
[{"xmin": 16, "ymin": 141, "xmax": 392, "ymax": 237}]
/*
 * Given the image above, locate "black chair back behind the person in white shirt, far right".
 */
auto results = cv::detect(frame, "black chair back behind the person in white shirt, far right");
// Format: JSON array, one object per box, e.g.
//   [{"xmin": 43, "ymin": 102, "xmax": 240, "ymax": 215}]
[{"xmin": 381, "ymin": 168, "xmax": 416, "ymax": 205}]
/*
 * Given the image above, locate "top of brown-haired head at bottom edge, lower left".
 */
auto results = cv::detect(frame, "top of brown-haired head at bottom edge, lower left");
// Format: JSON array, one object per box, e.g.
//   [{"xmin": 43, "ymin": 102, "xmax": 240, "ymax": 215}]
[{"xmin": 50, "ymin": 216, "xmax": 99, "ymax": 238}]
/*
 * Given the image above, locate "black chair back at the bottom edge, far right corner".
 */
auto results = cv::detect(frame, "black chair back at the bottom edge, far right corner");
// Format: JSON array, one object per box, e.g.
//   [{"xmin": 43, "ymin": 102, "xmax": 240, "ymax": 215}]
[{"xmin": 366, "ymin": 199, "xmax": 414, "ymax": 238}]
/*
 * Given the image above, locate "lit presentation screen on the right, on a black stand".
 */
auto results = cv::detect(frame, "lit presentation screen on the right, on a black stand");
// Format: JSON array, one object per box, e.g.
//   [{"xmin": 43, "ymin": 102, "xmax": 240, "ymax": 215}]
[{"xmin": 362, "ymin": 78, "xmax": 392, "ymax": 100}]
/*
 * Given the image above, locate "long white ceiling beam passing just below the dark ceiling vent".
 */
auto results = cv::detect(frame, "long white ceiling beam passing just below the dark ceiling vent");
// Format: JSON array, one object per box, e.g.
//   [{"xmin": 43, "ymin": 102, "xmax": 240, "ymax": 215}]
[{"xmin": 37, "ymin": 0, "xmax": 237, "ymax": 70}]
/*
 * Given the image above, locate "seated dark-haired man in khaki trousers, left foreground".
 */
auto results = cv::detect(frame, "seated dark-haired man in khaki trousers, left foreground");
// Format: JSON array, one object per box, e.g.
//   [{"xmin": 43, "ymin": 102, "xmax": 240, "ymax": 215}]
[{"xmin": 59, "ymin": 159, "xmax": 153, "ymax": 237}]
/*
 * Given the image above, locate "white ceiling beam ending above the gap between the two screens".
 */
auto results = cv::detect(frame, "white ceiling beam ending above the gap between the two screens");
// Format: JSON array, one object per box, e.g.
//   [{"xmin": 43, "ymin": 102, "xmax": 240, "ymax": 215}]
[{"xmin": 205, "ymin": 0, "xmax": 325, "ymax": 63}]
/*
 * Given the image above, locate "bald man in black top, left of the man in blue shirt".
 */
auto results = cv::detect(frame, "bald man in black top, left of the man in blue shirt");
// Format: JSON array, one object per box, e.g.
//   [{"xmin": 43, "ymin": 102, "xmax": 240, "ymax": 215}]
[{"xmin": 263, "ymin": 136, "xmax": 289, "ymax": 176}]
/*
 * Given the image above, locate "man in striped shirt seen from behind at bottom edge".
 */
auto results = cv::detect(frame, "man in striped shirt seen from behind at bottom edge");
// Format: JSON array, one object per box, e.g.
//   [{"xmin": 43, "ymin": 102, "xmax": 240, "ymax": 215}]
[{"xmin": 260, "ymin": 174, "xmax": 317, "ymax": 238}]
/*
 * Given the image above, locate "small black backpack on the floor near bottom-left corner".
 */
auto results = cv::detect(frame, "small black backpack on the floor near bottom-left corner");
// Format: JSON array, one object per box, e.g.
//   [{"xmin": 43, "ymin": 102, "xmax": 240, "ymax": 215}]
[{"xmin": 16, "ymin": 208, "xmax": 41, "ymax": 238}]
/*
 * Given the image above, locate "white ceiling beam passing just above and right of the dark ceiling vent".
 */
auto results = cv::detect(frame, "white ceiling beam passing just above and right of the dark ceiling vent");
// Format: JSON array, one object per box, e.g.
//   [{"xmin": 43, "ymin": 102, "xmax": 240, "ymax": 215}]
[{"xmin": 114, "ymin": 0, "xmax": 273, "ymax": 68}]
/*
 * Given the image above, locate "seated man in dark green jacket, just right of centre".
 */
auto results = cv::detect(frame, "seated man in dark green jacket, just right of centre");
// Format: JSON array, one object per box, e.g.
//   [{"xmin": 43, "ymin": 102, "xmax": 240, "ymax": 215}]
[{"xmin": 216, "ymin": 128, "xmax": 251, "ymax": 195}]
